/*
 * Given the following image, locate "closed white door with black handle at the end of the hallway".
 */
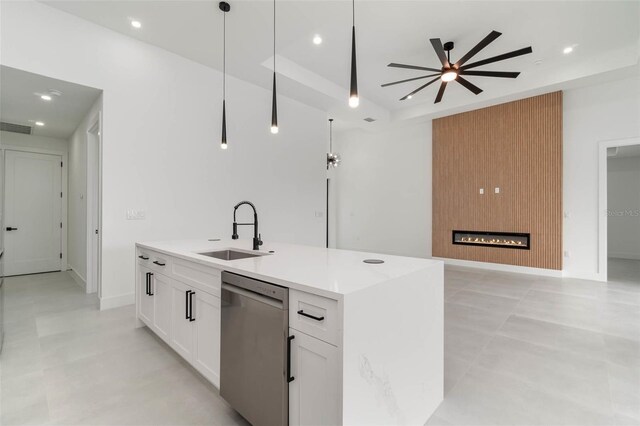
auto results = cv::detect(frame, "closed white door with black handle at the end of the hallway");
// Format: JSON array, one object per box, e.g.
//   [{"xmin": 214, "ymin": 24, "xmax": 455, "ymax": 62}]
[{"xmin": 3, "ymin": 150, "xmax": 62, "ymax": 275}]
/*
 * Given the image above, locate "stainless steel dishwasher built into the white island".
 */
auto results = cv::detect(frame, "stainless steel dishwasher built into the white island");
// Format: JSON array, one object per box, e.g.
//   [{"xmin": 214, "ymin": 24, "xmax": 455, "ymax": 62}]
[{"xmin": 220, "ymin": 272, "xmax": 293, "ymax": 426}]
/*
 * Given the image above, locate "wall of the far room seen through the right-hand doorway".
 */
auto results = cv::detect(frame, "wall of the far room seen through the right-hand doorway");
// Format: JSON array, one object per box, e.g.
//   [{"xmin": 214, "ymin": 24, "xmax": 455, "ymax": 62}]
[{"xmin": 607, "ymin": 153, "xmax": 640, "ymax": 260}]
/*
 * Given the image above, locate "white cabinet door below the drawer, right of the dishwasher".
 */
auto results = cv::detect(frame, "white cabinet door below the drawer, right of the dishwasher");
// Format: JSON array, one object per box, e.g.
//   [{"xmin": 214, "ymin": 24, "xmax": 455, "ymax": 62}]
[{"xmin": 289, "ymin": 328, "xmax": 341, "ymax": 425}]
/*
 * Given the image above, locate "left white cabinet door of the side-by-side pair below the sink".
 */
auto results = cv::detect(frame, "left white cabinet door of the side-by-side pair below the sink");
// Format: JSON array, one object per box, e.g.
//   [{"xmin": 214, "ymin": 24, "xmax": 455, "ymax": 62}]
[{"xmin": 171, "ymin": 281, "xmax": 194, "ymax": 361}]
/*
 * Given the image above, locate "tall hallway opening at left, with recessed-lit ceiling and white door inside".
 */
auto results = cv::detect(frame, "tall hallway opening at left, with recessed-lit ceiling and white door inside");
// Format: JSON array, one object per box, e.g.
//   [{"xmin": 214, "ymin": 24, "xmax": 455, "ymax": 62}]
[{"xmin": 0, "ymin": 66, "xmax": 102, "ymax": 295}]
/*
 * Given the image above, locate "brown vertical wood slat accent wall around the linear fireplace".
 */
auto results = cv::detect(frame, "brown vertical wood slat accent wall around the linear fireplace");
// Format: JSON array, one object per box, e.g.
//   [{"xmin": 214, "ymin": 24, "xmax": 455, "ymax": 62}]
[{"xmin": 432, "ymin": 92, "xmax": 562, "ymax": 269}]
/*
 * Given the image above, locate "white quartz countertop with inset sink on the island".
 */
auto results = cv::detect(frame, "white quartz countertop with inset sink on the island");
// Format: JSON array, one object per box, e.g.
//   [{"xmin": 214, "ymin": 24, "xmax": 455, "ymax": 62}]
[{"xmin": 136, "ymin": 239, "xmax": 442, "ymax": 300}]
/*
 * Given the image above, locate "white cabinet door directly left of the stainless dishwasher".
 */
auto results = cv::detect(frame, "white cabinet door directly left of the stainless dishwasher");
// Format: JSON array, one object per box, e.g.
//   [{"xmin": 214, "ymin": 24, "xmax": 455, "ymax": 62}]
[{"xmin": 192, "ymin": 290, "xmax": 220, "ymax": 387}]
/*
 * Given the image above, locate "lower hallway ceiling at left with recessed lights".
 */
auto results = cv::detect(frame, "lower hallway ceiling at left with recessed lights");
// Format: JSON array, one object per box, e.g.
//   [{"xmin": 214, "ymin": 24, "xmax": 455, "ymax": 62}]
[{"xmin": 0, "ymin": 66, "xmax": 102, "ymax": 139}]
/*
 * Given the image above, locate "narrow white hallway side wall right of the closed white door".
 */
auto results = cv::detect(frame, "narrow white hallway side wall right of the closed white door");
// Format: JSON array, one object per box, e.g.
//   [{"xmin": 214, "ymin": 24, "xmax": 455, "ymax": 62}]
[{"xmin": 67, "ymin": 97, "xmax": 102, "ymax": 283}]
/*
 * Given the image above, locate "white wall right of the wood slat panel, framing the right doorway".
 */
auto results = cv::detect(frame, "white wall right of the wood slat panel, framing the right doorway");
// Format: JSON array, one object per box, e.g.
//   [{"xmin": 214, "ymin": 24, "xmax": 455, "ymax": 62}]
[{"xmin": 563, "ymin": 77, "xmax": 640, "ymax": 279}]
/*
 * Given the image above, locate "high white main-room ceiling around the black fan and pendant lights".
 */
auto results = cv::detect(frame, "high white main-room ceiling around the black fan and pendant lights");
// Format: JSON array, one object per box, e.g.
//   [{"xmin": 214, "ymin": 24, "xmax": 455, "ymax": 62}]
[{"xmin": 45, "ymin": 0, "xmax": 640, "ymax": 126}]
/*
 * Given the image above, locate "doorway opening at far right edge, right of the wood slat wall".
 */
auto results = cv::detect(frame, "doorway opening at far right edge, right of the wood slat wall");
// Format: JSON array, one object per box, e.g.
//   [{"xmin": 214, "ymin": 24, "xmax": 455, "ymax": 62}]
[{"xmin": 599, "ymin": 139, "xmax": 640, "ymax": 286}]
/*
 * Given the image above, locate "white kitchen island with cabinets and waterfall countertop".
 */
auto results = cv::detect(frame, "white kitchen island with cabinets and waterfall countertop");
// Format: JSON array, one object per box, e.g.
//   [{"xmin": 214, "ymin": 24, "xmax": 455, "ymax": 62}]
[{"xmin": 136, "ymin": 239, "xmax": 444, "ymax": 425}]
